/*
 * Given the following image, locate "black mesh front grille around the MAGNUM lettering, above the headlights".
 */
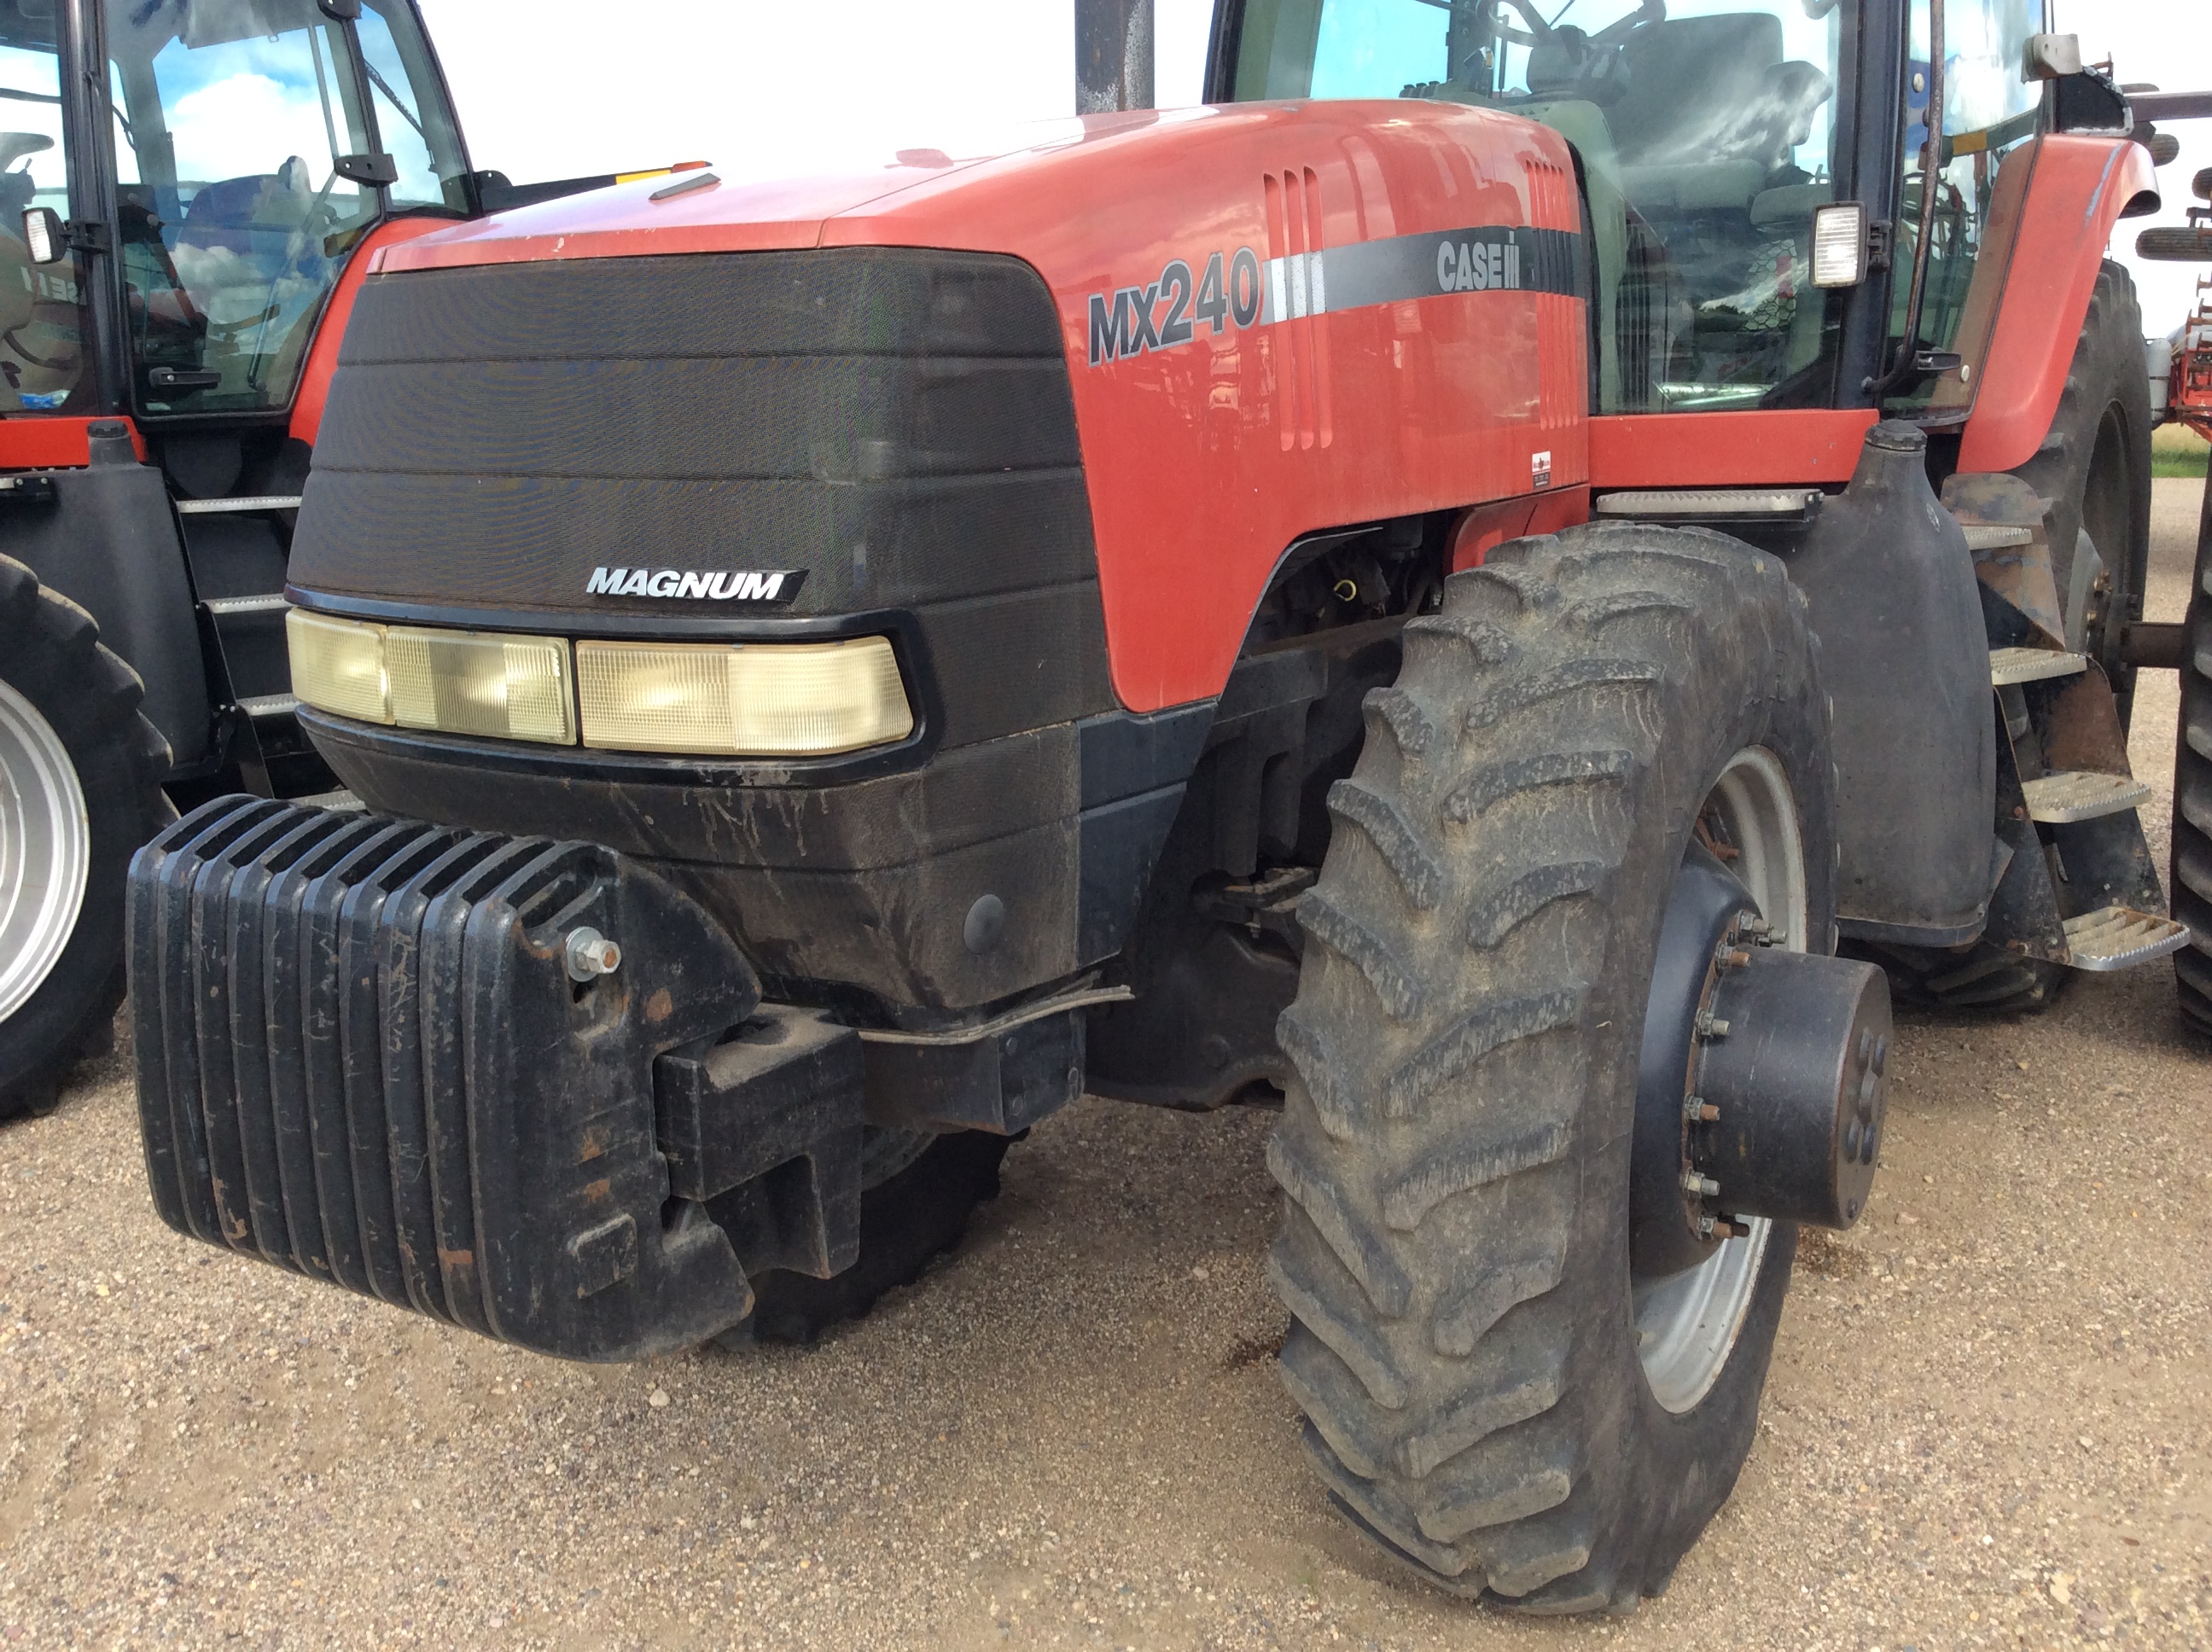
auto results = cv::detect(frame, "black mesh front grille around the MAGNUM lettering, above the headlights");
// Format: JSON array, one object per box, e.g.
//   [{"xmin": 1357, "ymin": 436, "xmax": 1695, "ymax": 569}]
[{"xmin": 290, "ymin": 247, "xmax": 1113, "ymax": 745}]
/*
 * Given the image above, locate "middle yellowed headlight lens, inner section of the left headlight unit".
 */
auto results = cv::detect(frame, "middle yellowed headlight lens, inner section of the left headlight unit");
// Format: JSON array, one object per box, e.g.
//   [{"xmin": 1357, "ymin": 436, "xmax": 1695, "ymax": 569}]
[{"xmin": 385, "ymin": 625, "xmax": 575, "ymax": 745}]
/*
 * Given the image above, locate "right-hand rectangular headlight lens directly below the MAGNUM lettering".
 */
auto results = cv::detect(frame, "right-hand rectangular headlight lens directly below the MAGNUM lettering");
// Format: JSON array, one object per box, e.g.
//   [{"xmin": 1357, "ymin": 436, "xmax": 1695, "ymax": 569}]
[{"xmin": 575, "ymin": 637, "xmax": 913, "ymax": 756}]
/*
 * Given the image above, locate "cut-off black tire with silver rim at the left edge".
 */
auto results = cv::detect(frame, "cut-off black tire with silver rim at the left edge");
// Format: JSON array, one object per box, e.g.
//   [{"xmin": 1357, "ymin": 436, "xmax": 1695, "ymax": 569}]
[{"xmin": 0, "ymin": 557, "xmax": 175, "ymax": 1119}]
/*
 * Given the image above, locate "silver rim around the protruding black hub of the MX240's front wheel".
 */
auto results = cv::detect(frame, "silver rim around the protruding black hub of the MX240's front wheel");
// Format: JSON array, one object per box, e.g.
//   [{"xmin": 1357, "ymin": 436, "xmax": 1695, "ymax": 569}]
[{"xmin": 1633, "ymin": 745, "xmax": 1809, "ymax": 1413}]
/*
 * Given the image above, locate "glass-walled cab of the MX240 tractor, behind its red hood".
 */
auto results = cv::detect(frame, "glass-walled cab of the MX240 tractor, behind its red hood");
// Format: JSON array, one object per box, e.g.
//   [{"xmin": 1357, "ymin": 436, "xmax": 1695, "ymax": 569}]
[{"xmin": 1217, "ymin": 0, "xmax": 2044, "ymax": 420}]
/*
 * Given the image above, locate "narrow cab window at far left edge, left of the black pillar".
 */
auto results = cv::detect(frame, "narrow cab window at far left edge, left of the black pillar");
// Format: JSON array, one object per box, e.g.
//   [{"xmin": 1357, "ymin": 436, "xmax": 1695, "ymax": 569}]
[{"xmin": 0, "ymin": 4, "xmax": 84, "ymax": 414}]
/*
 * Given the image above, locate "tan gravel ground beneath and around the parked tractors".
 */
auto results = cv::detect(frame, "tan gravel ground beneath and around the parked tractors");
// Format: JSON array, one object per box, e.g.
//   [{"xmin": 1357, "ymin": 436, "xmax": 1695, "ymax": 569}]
[{"xmin": 0, "ymin": 480, "xmax": 2212, "ymax": 1652}]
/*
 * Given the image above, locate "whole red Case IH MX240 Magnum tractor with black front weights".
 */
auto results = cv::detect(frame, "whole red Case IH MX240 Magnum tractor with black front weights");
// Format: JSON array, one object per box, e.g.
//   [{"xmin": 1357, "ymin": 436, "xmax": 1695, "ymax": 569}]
[{"xmin": 116, "ymin": 0, "xmax": 2212, "ymax": 1612}]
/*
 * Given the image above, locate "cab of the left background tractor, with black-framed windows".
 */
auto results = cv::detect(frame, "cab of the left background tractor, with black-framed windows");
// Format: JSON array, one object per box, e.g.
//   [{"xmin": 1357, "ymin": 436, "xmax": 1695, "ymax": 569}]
[{"xmin": 0, "ymin": 0, "xmax": 471, "ymax": 427}]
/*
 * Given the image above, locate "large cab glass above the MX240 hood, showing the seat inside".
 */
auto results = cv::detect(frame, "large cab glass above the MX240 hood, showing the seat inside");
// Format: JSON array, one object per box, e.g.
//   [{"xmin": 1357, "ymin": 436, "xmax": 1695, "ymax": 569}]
[{"xmin": 1234, "ymin": 0, "xmax": 1856, "ymax": 411}]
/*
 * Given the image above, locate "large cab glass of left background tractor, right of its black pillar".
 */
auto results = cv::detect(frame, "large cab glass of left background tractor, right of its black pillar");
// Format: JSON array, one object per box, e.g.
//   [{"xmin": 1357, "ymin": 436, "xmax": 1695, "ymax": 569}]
[{"xmin": 106, "ymin": 0, "xmax": 467, "ymax": 414}]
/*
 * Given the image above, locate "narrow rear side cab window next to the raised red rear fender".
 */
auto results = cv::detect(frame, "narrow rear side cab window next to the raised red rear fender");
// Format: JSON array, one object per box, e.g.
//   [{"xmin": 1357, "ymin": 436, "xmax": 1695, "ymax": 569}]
[{"xmin": 1889, "ymin": 0, "xmax": 2044, "ymax": 411}]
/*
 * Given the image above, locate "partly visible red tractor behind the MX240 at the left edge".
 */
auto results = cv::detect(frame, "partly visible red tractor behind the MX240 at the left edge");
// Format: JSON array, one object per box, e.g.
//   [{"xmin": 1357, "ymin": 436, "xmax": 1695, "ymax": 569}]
[{"xmin": 0, "ymin": 0, "xmax": 699, "ymax": 1119}]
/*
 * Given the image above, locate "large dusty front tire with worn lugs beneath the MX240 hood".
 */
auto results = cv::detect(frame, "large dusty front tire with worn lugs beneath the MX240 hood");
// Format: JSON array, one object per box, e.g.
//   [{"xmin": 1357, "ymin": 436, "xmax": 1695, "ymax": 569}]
[{"xmin": 1267, "ymin": 524, "xmax": 1836, "ymax": 1612}]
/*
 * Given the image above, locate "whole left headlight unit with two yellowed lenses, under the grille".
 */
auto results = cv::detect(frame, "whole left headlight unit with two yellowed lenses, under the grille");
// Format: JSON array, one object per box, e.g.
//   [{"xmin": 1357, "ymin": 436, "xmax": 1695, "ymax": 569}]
[{"xmin": 285, "ymin": 608, "xmax": 575, "ymax": 745}]
